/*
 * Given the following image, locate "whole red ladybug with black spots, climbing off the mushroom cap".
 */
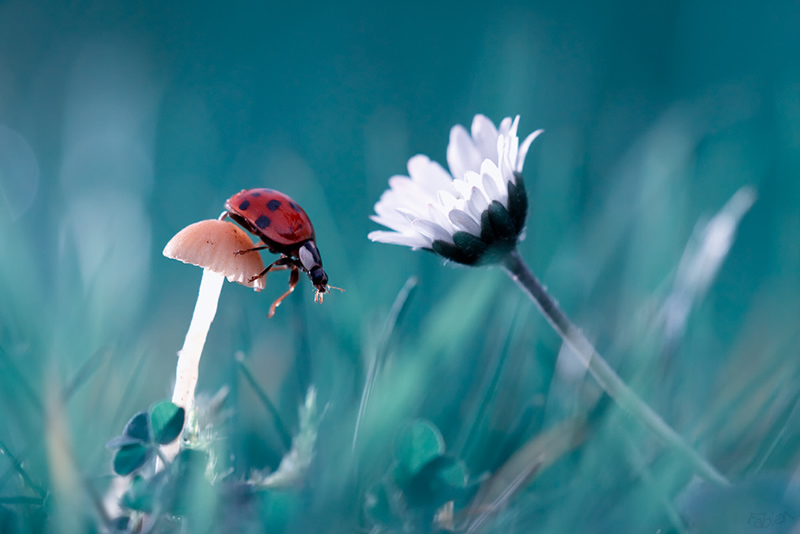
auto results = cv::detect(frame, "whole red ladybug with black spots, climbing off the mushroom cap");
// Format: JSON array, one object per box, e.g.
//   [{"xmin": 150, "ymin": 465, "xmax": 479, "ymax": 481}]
[{"xmin": 220, "ymin": 188, "xmax": 339, "ymax": 317}]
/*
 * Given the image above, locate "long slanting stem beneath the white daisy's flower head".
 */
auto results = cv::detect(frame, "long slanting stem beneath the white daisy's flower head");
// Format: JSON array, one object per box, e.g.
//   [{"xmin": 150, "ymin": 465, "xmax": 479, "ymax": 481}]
[{"xmin": 502, "ymin": 249, "xmax": 728, "ymax": 486}]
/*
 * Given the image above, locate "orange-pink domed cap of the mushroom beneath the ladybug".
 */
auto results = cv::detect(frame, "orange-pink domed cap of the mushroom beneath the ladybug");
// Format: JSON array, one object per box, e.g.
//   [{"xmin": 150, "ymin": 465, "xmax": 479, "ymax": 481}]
[{"xmin": 164, "ymin": 219, "xmax": 265, "ymax": 291}]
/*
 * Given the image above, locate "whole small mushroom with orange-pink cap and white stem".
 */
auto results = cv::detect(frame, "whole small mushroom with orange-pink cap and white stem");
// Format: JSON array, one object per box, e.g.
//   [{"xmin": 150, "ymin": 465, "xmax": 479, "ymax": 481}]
[{"xmin": 164, "ymin": 219, "xmax": 264, "ymax": 456}]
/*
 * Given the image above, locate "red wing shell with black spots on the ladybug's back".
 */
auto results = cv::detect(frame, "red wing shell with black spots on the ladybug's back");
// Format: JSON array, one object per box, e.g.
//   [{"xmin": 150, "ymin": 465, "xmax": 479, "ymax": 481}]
[{"xmin": 225, "ymin": 188, "xmax": 314, "ymax": 252}]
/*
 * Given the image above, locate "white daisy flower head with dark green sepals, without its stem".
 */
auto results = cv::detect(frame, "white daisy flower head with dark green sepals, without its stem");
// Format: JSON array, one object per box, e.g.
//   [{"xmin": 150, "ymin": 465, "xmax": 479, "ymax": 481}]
[{"xmin": 368, "ymin": 115, "xmax": 542, "ymax": 265}]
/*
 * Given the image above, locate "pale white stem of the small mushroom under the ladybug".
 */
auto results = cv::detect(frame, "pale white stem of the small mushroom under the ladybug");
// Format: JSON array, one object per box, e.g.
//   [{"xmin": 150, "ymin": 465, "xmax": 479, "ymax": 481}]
[{"xmin": 163, "ymin": 269, "xmax": 225, "ymax": 460}]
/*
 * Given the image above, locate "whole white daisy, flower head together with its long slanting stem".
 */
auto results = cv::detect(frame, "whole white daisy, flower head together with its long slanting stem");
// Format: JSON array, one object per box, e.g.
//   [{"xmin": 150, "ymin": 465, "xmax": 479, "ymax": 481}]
[{"xmin": 369, "ymin": 115, "xmax": 728, "ymax": 487}]
